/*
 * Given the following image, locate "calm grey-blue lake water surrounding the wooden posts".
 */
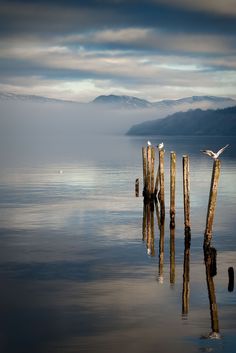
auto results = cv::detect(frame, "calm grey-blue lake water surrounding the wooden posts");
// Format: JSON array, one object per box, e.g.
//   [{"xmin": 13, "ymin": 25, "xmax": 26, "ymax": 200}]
[{"xmin": 0, "ymin": 136, "xmax": 236, "ymax": 353}]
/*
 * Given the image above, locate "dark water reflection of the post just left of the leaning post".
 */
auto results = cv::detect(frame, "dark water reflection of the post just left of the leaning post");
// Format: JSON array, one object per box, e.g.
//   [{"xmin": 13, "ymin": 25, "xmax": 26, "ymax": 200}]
[{"xmin": 182, "ymin": 228, "xmax": 191, "ymax": 318}]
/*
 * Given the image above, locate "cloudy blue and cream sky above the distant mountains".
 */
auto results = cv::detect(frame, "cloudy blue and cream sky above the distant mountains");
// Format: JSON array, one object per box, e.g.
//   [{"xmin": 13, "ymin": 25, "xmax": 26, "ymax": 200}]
[{"xmin": 0, "ymin": 0, "xmax": 236, "ymax": 102}]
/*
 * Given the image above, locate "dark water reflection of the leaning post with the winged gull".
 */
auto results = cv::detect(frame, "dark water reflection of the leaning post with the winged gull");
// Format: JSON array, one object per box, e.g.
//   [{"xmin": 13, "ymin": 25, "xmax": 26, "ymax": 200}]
[{"xmin": 204, "ymin": 246, "xmax": 220, "ymax": 339}]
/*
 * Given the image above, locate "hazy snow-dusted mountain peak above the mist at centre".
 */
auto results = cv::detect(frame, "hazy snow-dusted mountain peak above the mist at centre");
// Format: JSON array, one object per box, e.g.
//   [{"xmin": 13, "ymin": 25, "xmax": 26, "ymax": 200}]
[{"xmin": 91, "ymin": 94, "xmax": 153, "ymax": 109}]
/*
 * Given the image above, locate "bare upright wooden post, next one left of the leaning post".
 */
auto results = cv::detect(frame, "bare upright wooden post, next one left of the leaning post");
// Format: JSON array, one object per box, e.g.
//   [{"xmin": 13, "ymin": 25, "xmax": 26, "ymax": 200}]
[{"xmin": 183, "ymin": 156, "xmax": 190, "ymax": 231}]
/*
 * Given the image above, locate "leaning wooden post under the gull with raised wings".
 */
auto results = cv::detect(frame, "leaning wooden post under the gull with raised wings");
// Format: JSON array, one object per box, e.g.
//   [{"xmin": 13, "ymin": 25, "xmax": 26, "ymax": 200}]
[{"xmin": 204, "ymin": 159, "xmax": 220, "ymax": 246}]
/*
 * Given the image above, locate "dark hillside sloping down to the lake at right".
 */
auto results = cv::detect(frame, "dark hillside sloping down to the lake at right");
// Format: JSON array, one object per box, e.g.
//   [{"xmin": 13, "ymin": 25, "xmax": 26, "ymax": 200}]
[{"xmin": 127, "ymin": 106, "xmax": 236, "ymax": 136}]
